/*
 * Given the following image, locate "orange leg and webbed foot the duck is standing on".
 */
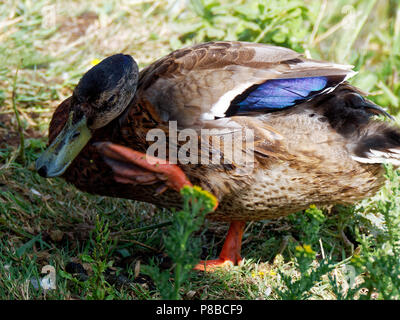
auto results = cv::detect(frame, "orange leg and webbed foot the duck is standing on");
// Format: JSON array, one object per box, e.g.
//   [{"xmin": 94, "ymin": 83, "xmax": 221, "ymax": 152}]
[{"xmin": 194, "ymin": 221, "xmax": 246, "ymax": 271}]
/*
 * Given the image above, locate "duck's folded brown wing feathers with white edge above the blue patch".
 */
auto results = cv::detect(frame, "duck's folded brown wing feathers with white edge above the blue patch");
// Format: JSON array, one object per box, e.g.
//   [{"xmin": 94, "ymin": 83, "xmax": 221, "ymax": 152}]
[{"xmin": 138, "ymin": 41, "xmax": 354, "ymax": 127}]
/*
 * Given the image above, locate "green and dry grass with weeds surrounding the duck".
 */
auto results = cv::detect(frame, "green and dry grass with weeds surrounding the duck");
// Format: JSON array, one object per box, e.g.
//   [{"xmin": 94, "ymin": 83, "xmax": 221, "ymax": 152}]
[{"xmin": 0, "ymin": 0, "xmax": 400, "ymax": 299}]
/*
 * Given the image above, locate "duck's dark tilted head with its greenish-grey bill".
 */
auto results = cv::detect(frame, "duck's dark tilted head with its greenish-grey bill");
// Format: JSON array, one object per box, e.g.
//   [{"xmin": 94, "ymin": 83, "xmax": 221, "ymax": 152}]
[{"xmin": 36, "ymin": 54, "xmax": 139, "ymax": 178}]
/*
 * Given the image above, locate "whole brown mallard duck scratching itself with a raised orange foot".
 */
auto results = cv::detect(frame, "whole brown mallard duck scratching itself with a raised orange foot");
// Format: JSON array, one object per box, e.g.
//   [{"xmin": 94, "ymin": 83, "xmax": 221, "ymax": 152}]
[{"xmin": 36, "ymin": 41, "xmax": 400, "ymax": 270}]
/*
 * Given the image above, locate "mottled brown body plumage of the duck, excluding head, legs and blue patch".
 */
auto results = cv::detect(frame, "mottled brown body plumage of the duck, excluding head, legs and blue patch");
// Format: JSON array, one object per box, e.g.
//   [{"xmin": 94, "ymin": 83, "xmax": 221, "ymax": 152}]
[{"xmin": 42, "ymin": 42, "xmax": 400, "ymax": 221}]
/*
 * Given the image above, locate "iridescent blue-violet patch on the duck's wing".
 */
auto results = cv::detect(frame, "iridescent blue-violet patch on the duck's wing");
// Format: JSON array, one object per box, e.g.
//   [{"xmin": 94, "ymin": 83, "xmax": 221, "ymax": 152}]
[{"xmin": 237, "ymin": 77, "xmax": 328, "ymax": 112}]
